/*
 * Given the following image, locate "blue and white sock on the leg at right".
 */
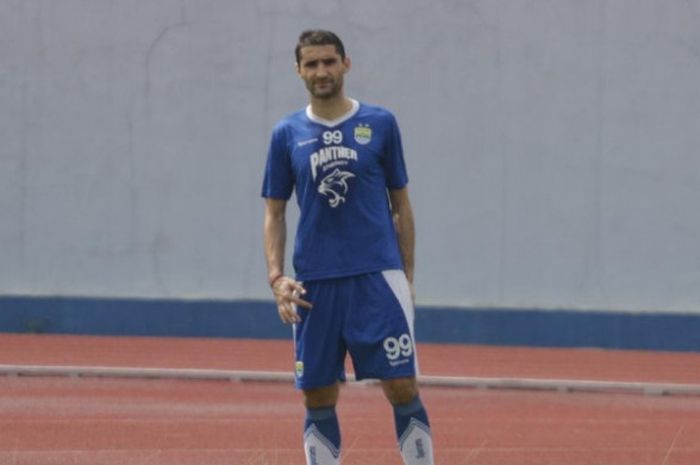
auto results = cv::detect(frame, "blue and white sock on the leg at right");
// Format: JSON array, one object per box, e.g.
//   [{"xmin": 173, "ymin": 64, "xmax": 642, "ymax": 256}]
[{"xmin": 394, "ymin": 396, "xmax": 433, "ymax": 465}]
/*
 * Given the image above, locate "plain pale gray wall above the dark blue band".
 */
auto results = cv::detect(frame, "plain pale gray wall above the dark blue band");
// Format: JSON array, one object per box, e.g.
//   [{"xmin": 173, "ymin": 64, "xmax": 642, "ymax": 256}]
[{"xmin": 0, "ymin": 0, "xmax": 700, "ymax": 312}]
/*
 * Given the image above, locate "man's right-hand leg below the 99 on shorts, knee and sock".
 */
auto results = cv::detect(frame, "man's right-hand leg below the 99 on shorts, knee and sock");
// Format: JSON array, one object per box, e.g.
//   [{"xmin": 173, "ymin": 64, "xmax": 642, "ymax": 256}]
[{"xmin": 382, "ymin": 377, "xmax": 434, "ymax": 465}]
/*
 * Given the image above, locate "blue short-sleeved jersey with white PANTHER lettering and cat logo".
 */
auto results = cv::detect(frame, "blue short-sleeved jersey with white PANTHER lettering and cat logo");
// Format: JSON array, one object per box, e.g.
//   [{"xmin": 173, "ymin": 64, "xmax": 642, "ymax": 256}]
[{"xmin": 262, "ymin": 101, "xmax": 408, "ymax": 281}]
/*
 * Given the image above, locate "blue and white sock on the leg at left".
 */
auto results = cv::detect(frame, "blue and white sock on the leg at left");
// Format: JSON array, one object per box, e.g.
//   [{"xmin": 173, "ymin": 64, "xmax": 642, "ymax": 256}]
[{"xmin": 304, "ymin": 407, "xmax": 340, "ymax": 465}]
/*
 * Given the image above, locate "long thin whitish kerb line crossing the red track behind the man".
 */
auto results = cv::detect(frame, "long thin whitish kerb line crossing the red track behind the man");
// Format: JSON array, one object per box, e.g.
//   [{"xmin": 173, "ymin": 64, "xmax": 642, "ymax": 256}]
[{"xmin": 0, "ymin": 365, "xmax": 700, "ymax": 396}]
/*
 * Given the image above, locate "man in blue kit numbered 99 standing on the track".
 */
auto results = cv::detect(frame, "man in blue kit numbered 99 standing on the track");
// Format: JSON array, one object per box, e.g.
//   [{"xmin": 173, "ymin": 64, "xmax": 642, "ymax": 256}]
[{"xmin": 262, "ymin": 30, "xmax": 433, "ymax": 465}]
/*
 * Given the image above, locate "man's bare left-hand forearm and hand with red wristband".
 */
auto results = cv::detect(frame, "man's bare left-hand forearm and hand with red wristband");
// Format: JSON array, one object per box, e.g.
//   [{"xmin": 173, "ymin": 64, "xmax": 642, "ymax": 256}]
[{"xmin": 263, "ymin": 198, "xmax": 311, "ymax": 323}]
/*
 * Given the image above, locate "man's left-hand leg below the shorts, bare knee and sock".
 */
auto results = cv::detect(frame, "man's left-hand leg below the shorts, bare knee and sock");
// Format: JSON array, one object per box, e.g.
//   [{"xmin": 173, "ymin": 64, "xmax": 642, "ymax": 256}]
[{"xmin": 304, "ymin": 383, "xmax": 340, "ymax": 465}]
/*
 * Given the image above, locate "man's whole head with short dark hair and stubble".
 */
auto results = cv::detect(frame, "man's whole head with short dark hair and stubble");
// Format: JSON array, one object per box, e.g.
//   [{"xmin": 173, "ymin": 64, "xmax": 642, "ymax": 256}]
[{"xmin": 294, "ymin": 30, "xmax": 350, "ymax": 99}]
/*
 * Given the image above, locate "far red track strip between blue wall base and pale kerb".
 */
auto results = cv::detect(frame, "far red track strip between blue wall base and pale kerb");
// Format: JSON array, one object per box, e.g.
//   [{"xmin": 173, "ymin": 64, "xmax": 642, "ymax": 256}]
[{"xmin": 0, "ymin": 334, "xmax": 700, "ymax": 384}]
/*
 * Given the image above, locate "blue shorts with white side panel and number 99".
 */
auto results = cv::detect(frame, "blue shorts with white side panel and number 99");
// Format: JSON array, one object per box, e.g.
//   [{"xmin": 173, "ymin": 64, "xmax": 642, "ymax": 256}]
[{"xmin": 294, "ymin": 270, "xmax": 418, "ymax": 389}]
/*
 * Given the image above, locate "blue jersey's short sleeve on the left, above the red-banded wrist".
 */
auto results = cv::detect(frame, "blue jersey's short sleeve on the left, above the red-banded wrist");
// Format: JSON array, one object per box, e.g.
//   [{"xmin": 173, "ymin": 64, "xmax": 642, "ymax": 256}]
[{"xmin": 262, "ymin": 127, "xmax": 294, "ymax": 200}]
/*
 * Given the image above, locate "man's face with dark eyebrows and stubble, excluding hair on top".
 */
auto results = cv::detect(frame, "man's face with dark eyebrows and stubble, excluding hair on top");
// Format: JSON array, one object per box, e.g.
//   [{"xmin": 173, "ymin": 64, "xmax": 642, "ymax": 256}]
[{"xmin": 297, "ymin": 45, "xmax": 350, "ymax": 99}]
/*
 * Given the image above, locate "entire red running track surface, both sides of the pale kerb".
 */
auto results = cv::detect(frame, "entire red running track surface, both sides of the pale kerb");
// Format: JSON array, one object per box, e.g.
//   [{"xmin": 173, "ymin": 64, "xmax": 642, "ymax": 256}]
[{"xmin": 0, "ymin": 335, "xmax": 700, "ymax": 465}]
